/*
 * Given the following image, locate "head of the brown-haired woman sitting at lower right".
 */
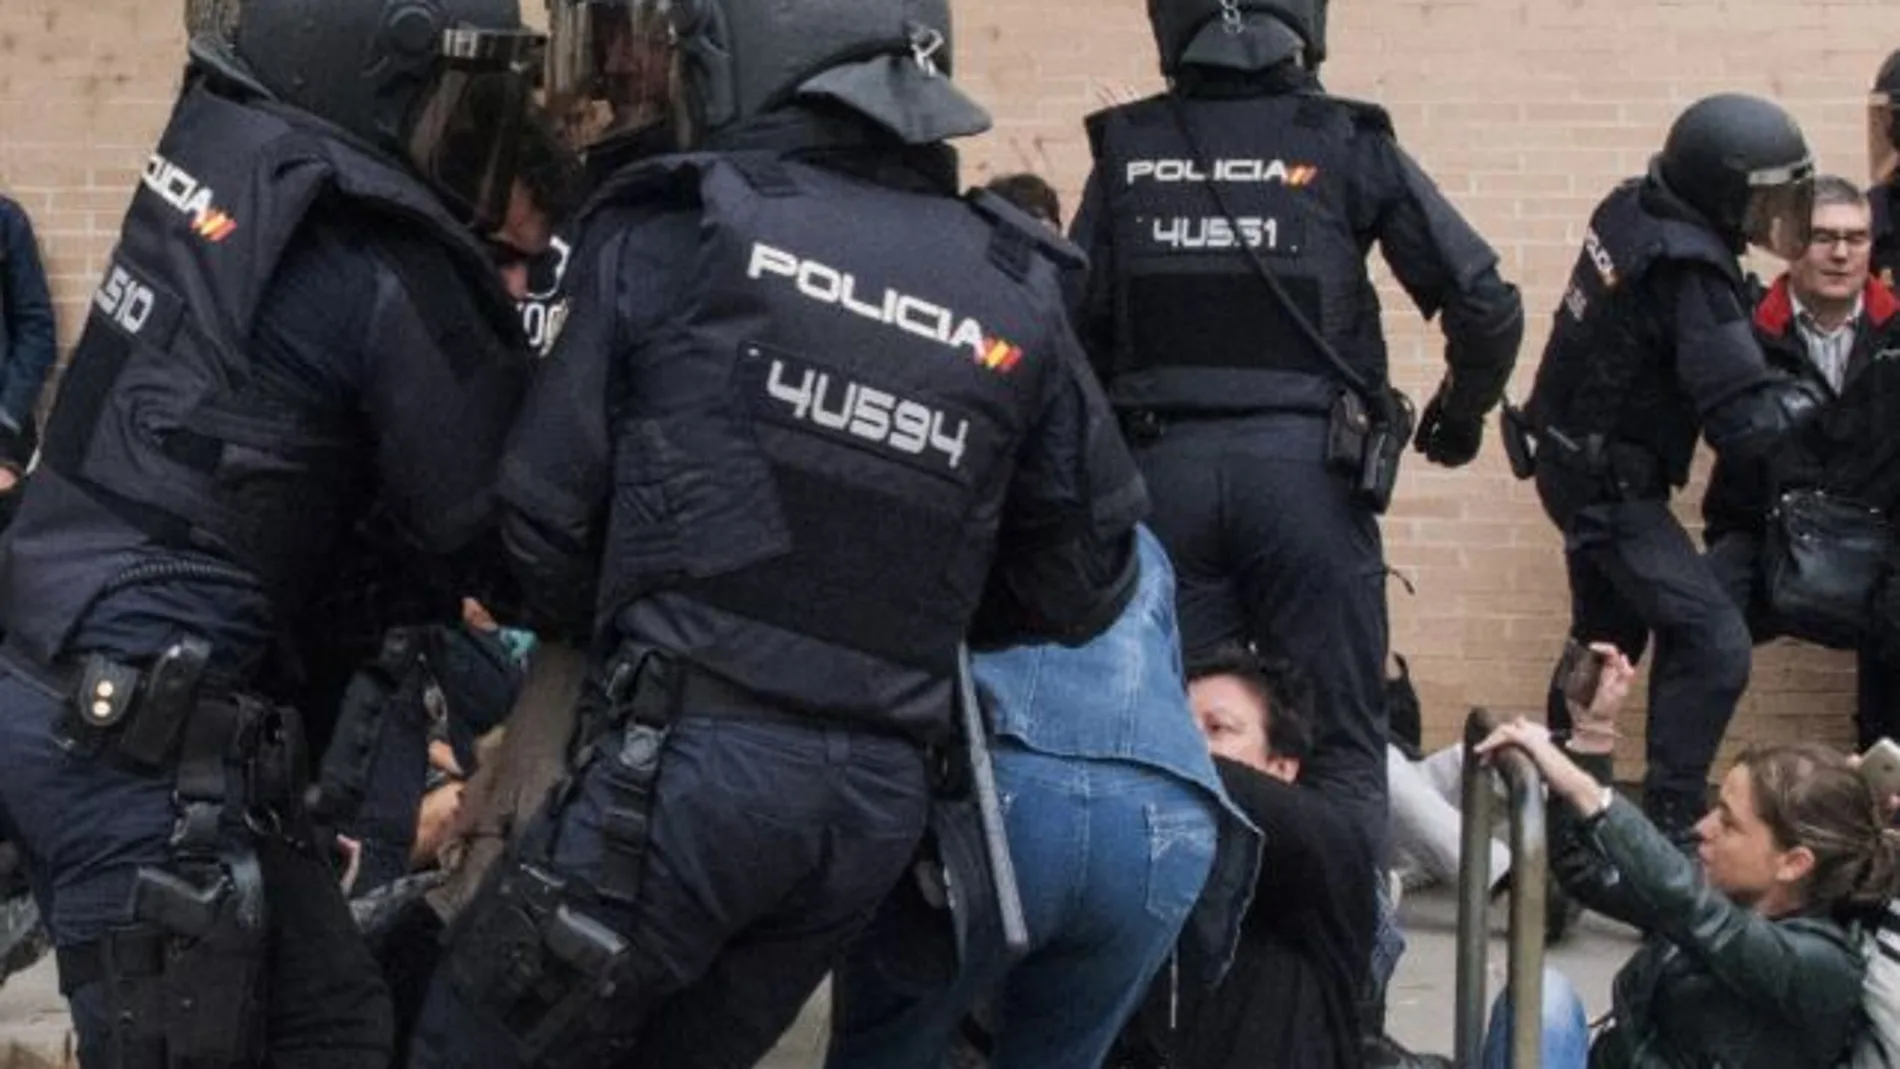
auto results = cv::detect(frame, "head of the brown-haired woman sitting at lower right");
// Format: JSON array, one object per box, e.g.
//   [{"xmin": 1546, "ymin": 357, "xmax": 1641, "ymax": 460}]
[{"xmin": 1697, "ymin": 744, "xmax": 1900, "ymax": 917}]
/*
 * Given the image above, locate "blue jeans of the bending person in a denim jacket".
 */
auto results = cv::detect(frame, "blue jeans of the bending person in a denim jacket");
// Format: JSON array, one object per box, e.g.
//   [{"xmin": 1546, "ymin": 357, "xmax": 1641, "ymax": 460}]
[{"xmin": 827, "ymin": 741, "xmax": 1216, "ymax": 1069}]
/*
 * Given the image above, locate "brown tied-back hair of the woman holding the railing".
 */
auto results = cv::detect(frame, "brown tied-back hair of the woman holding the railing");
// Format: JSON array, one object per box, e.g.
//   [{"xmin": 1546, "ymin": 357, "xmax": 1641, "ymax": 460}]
[{"xmin": 1739, "ymin": 742, "xmax": 1900, "ymax": 913}]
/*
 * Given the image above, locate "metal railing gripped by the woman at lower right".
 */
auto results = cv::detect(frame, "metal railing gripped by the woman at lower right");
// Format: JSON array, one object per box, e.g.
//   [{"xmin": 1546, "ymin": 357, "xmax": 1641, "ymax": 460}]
[{"xmin": 1457, "ymin": 708, "xmax": 1550, "ymax": 1069}]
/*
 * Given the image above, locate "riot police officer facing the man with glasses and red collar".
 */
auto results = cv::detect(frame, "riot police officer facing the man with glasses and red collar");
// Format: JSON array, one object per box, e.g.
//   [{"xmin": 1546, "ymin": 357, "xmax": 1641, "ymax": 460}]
[{"xmin": 1528, "ymin": 95, "xmax": 1820, "ymax": 843}]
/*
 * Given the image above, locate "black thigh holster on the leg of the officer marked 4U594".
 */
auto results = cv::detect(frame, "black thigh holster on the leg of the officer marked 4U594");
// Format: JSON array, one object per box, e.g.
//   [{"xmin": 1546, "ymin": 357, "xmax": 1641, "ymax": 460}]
[{"xmin": 445, "ymin": 858, "xmax": 629, "ymax": 1065}]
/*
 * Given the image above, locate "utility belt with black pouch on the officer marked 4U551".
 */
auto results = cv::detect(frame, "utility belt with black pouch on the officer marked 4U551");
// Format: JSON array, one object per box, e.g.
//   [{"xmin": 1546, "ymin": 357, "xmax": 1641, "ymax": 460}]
[{"xmin": 1119, "ymin": 385, "xmax": 1417, "ymax": 515}]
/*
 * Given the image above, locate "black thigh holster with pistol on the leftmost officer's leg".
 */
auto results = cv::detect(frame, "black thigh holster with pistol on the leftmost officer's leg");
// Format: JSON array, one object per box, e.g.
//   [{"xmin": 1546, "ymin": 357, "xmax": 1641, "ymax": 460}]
[{"xmin": 80, "ymin": 853, "xmax": 266, "ymax": 1069}]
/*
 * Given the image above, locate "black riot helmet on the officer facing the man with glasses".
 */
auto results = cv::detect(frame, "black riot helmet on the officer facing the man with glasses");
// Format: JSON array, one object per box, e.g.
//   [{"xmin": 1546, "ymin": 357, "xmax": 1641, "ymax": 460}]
[{"xmin": 1655, "ymin": 93, "xmax": 1815, "ymax": 260}]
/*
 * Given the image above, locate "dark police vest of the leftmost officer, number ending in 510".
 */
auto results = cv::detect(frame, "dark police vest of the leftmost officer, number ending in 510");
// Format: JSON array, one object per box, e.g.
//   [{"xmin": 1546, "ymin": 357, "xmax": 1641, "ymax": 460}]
[{"xmin": 0, "ymin": 85, "xmax": 526, "ymax": 661}]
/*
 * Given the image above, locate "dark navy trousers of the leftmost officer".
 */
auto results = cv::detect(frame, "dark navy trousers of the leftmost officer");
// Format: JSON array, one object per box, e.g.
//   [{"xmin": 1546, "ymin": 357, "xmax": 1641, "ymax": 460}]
[{"xmin": 0, "ymin": 668, "xmax": 393, "ymax": 1069}]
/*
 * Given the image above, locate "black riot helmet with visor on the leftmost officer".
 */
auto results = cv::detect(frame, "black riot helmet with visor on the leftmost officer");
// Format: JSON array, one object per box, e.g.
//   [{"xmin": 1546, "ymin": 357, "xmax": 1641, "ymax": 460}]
[{"xmin": 184, "ymin": 0, "xmax": 547, "ymax": 232}]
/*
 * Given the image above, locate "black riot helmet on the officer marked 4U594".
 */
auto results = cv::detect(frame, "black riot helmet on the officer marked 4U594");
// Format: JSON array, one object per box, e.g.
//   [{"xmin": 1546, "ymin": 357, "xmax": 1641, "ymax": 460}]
[{"xmin": 547, "ymin": 0, "xmax": 990, "ymax": 148}]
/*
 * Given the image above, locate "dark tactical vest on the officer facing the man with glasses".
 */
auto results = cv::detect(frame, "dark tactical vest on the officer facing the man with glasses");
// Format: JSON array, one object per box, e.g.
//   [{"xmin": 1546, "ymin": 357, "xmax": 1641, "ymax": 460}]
[{"xmin": 1528, "ymin": 178, "xmax": 1750, "ymax": 486}]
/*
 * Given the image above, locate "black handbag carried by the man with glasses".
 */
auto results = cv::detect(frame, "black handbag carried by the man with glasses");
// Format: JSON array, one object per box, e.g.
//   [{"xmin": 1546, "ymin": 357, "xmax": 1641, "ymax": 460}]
[{"xmin": 1761, "ymin": 490, "xmax": 1892, "ymax": 649}]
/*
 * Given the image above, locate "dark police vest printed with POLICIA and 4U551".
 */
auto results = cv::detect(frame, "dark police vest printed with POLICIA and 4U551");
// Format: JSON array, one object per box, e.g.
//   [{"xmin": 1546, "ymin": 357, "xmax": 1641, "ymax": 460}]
[{"xmin": 1089, "ymin": 93, "xmax": 1391, "ymax": 410}]
